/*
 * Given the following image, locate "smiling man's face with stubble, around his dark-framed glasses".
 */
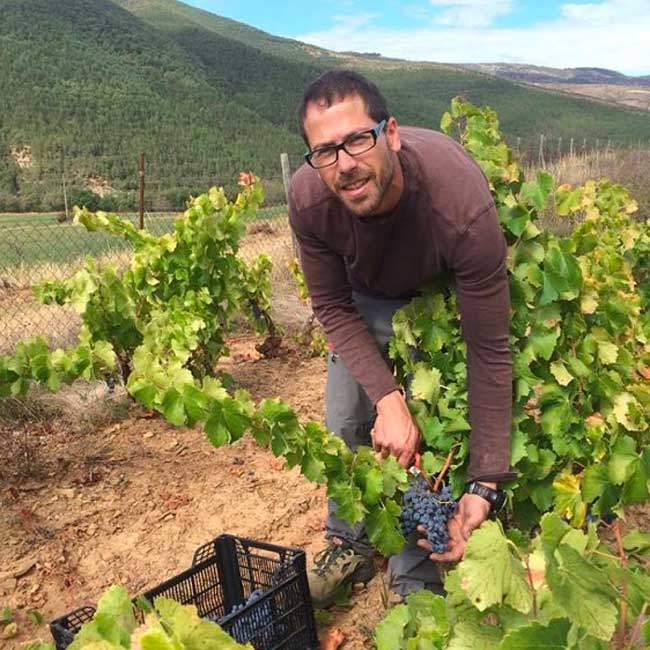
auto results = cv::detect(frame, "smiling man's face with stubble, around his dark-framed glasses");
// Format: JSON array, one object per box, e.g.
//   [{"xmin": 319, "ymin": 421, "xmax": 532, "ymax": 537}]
[{"xmin": 304, "ymin": 95, "xmax": 403, "ymax": 216}]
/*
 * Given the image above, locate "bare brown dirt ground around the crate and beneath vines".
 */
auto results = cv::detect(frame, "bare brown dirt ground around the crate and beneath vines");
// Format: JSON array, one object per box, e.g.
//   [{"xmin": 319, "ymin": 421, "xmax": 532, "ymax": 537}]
[{"xmin": 0, "ymin": 337, "xmax": 384, "ymax": 650}]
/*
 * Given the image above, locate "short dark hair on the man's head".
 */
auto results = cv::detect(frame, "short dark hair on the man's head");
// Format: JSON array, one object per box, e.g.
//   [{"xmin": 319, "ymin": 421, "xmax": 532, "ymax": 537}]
[{"xmin": 300, "ymin": 70, "xmax": 390, "ymax": 146}]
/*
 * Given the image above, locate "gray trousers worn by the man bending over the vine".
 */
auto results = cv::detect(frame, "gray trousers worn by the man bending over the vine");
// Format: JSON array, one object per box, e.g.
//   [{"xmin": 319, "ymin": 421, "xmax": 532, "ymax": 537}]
[{"xmin": 325, "ymin": 294, "xmax": 442, "ymax": 596}]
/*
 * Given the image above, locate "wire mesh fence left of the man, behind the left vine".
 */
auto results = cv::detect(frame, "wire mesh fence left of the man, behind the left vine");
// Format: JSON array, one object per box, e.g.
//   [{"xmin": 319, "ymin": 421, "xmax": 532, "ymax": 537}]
[{"xmin": 0, "ymin": 205, "xmax": 299, "ymax": 354}]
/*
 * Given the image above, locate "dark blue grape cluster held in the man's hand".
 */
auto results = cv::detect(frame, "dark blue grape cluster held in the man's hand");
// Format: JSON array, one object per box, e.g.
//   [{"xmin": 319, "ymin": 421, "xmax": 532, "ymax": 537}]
[{"xmin": 401, "ymin": 478, "xmax": 456, "ymax": 553}]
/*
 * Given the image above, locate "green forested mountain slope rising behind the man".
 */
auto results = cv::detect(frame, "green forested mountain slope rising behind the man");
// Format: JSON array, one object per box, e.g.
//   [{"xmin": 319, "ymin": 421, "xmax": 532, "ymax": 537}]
[{"xmin": 0, "ymin": 0, "xmax": 650, "ymax": 210}]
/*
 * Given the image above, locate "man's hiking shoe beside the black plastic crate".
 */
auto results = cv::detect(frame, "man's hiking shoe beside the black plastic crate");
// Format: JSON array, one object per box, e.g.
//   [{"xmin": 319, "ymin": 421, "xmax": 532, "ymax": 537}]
[{"xmin": 308, "ymin": 544, "xmax": 375, "ymax": 609}]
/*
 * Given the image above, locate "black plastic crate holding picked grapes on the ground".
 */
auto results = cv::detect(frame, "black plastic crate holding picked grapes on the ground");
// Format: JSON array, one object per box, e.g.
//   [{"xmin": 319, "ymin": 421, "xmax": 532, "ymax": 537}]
[{"xmin": 50, "ymin": 535, "xmax": 318, "ymax": 650}]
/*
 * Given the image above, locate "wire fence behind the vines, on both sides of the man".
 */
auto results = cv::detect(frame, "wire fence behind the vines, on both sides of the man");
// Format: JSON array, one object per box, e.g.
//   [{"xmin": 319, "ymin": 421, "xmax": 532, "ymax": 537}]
[{"xmin": 0, "ymin": 136, "xmax": 650, "ymax": 354}]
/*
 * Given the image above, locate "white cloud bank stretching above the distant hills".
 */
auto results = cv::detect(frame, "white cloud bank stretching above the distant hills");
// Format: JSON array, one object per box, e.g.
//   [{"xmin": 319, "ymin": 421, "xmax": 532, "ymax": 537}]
[{"xmin": 292, "ymin": 0, "xmax": 650, "ymax": 74}]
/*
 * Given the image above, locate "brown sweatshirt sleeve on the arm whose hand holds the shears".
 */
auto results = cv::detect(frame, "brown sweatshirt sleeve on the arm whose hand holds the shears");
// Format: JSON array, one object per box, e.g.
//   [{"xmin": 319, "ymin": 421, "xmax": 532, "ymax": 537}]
[{"xmin": 289, "ymin": 200, "xmax": 397, "ymax": 404}]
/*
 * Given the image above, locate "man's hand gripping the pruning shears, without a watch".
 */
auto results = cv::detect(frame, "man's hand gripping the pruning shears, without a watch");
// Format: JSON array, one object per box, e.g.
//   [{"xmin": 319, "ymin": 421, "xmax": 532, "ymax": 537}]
[{"xmin": 372, "ymin": 390, "xmax": 420, "ymax": 467}]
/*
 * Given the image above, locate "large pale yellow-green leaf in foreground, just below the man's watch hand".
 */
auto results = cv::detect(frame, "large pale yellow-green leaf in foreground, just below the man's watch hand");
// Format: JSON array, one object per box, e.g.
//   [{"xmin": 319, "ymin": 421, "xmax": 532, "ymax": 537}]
[{"xmin": 458, "ymin": 521, "xmax": 533, "ymax": 614}]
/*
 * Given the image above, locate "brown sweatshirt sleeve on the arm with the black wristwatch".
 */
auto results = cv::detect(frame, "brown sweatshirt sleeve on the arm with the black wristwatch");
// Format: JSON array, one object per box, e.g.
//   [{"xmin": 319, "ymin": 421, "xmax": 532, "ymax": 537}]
[{"xmin": 450, "ymin": 205, "xmax": 515, "ymax": 481}]
